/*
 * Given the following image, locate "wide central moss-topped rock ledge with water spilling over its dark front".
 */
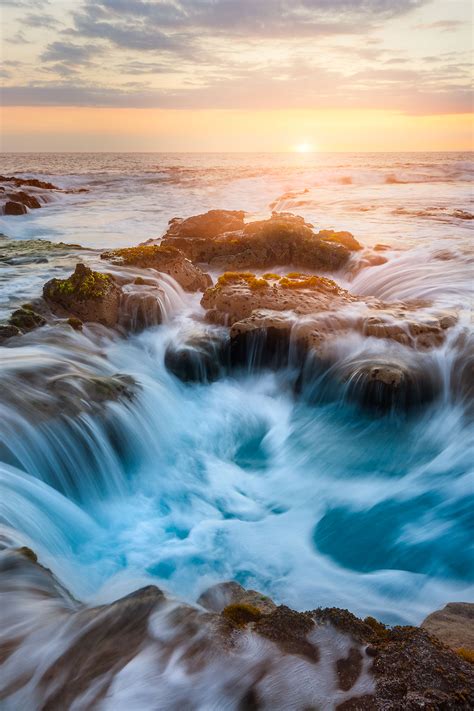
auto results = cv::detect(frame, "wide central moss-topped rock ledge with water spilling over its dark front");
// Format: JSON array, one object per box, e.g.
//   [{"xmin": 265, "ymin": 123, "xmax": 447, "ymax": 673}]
[{"xmin": 165, "ymin": 272, "xmax": 456, "ymax": 412}]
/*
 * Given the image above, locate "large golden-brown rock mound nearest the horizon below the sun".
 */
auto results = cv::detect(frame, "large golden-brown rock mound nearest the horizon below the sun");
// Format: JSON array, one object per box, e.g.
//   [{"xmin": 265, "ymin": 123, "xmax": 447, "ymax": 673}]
[{"xmin": 162, "ymin": 210, "xmax": 361, "ymax": 271}]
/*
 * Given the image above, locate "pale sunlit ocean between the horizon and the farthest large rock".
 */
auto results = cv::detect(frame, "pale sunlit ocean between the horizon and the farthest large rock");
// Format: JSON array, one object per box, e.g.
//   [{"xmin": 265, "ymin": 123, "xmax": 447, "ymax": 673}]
[{"xmin": 0, "ymin": 153, "xmax": 474, "ymax": 248}]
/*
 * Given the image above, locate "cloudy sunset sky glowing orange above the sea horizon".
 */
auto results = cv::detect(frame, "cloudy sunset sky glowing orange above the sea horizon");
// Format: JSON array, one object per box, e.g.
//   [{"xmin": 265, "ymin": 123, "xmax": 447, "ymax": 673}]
[{"xmin": 0, "ymin": 0, "xmax": 474, "ymax": 151}]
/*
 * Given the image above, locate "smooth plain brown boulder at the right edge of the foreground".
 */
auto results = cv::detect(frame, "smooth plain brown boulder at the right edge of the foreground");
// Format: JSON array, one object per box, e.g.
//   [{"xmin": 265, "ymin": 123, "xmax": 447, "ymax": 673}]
[{"xmin": 421, "ymin": 602, "xmax": 474, "ymax": 652}]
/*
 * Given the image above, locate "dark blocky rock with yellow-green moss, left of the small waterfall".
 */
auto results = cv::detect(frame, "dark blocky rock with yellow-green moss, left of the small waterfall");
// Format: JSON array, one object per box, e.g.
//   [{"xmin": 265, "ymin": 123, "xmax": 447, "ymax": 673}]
[{"xmin": 43, "ymin": 264, "xmax": 121, "ymax": 327}]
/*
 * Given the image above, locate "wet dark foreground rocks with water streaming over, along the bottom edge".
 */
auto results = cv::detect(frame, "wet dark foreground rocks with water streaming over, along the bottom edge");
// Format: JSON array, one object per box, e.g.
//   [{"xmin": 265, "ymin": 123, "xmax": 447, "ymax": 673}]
[{"xmin": 0, "ymin": 547, "xmax": 474, "ymax": 711}]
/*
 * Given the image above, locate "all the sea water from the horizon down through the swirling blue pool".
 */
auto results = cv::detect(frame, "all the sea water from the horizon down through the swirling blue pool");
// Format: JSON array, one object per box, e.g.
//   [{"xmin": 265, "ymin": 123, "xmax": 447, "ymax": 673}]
[{"xmin": 0, "ymin": 153, "xmax": 474, "ymax": 622}]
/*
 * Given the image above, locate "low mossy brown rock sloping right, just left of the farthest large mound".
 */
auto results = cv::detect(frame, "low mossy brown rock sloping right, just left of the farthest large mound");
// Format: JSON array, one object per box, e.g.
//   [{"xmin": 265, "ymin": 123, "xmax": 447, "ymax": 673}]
[{"xmin": 101, "ymin": 245, "xmax": 212, "ymax": 291}]
